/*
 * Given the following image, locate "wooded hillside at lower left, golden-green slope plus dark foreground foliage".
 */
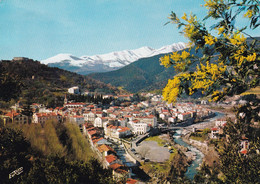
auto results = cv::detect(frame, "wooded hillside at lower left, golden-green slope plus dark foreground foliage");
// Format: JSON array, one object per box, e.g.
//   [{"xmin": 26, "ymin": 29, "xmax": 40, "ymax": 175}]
[{"xmin": 0, "ymin": 121, "xmax": 113, "ymax": 184}]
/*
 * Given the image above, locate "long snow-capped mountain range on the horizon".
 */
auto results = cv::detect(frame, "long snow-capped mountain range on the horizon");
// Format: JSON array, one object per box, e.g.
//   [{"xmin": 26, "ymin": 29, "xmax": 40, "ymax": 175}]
[{"xmin": 41, "ymin": 42, "xmax": 187, "ymax": 74}]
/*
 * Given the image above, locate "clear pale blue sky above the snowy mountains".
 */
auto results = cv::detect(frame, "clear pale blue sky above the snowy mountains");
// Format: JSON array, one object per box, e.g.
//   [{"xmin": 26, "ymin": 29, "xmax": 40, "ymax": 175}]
[{"xmin": 0, "ymin": 0, "xmax": 259, "ymax": 60}]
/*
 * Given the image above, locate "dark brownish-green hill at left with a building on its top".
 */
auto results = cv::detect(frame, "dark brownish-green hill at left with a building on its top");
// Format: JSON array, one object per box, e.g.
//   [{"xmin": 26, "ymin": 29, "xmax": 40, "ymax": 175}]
[{"xmin": 0, "ymin": 58, "xmax": 119, "ymax": 106}]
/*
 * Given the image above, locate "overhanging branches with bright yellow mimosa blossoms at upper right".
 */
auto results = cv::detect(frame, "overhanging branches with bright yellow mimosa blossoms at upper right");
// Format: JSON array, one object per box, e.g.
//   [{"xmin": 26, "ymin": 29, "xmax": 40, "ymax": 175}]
[{"xmin": 160, "ymin": 0, "xmax": 260, "ymax": 102}]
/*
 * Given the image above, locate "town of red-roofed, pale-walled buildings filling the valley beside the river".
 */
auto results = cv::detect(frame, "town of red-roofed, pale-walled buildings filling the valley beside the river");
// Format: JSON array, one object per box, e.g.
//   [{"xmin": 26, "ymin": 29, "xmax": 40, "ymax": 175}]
[{"xmin": 1, "ymin": 86, "xmax": 254, "ymax": 183}]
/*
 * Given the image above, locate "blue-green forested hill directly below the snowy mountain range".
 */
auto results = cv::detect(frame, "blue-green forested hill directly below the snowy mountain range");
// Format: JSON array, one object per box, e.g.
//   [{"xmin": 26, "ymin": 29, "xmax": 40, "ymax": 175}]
[{"xmin": 88, "ymin": 49, "xmax": 201, "ymax": 92}]
